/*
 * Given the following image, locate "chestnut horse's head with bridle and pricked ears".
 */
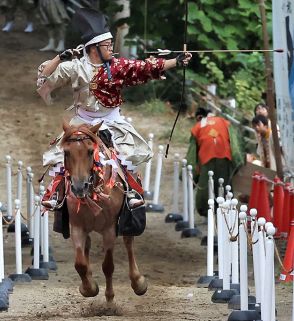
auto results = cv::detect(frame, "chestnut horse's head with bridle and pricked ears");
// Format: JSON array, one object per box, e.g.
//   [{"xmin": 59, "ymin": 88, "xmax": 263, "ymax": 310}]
[{"xmin": 61, "ymin": 122, "xmax": 102, "ymax": 198}]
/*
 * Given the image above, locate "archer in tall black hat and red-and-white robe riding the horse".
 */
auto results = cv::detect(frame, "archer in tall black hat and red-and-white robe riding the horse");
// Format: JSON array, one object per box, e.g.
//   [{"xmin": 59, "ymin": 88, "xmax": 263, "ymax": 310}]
[{"xmin": 38, "ymin": 8, "xmax": 192, "ymax": 215}]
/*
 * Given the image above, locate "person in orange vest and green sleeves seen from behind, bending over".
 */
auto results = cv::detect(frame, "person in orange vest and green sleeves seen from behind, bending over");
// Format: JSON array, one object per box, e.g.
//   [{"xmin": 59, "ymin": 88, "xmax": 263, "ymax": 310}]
[{"xmin": 187, "ymin": 108, "xmax": 245, "ymax": 216}]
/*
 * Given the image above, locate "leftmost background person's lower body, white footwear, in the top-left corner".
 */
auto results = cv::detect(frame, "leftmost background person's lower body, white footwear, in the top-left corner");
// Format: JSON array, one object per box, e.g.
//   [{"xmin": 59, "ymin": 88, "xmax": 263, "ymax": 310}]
[{"xmin": 0, "ymin": 0, "xmax": 36, "ymax": 32}]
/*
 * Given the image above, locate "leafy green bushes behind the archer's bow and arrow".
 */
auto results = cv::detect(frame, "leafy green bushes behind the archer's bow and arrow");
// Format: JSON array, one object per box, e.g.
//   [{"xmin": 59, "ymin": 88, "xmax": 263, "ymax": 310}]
[{"xmin": 101, "ymin": 0, "xmax": 271, "ymax": 113}]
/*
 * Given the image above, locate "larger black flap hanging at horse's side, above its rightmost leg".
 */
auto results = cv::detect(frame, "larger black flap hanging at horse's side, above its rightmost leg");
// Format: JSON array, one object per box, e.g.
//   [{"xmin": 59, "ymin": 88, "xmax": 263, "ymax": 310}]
[{"xmin": 117, "ymin": 202, "xmax": 146, "ymax": 236}]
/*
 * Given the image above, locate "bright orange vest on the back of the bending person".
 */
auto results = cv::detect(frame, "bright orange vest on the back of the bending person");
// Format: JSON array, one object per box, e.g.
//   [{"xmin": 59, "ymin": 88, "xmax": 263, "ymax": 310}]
[{"xmin": 191, "ymin": 116, "xmax": 232, "ymax": 165}]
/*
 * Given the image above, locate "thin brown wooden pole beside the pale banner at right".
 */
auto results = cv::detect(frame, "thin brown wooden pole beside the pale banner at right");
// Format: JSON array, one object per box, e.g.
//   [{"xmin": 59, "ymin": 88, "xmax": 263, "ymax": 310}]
[{"xmin": 259, "ymin": 0, "xmax": 283, "ymax": 179}]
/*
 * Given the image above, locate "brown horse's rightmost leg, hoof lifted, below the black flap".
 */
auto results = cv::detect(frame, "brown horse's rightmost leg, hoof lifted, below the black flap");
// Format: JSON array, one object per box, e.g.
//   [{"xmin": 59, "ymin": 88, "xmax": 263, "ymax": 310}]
[{"xmin": 123, "ymin": 236, "xmax": 147, "ymax": 295}]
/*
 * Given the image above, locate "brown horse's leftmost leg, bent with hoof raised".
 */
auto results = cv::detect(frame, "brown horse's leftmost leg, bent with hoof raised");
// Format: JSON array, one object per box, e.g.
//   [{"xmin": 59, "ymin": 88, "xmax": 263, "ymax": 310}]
[{"xmin": 71, "ymin": 227, "xmax": 99, "ymax": 297}]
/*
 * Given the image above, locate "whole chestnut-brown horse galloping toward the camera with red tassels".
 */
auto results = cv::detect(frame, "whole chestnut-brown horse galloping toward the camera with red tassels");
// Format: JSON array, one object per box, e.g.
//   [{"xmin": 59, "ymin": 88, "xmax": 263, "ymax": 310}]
[{"xmin": 61, "ymin": 123, "xmax": 147, "ymax": 302}]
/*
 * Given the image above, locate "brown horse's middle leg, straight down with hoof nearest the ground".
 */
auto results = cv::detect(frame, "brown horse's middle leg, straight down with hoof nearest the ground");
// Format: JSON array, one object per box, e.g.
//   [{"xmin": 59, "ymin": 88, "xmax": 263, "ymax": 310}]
[{"xmin": 102, "ymin": 229, "xmax": 116, "ymax": 302}]
